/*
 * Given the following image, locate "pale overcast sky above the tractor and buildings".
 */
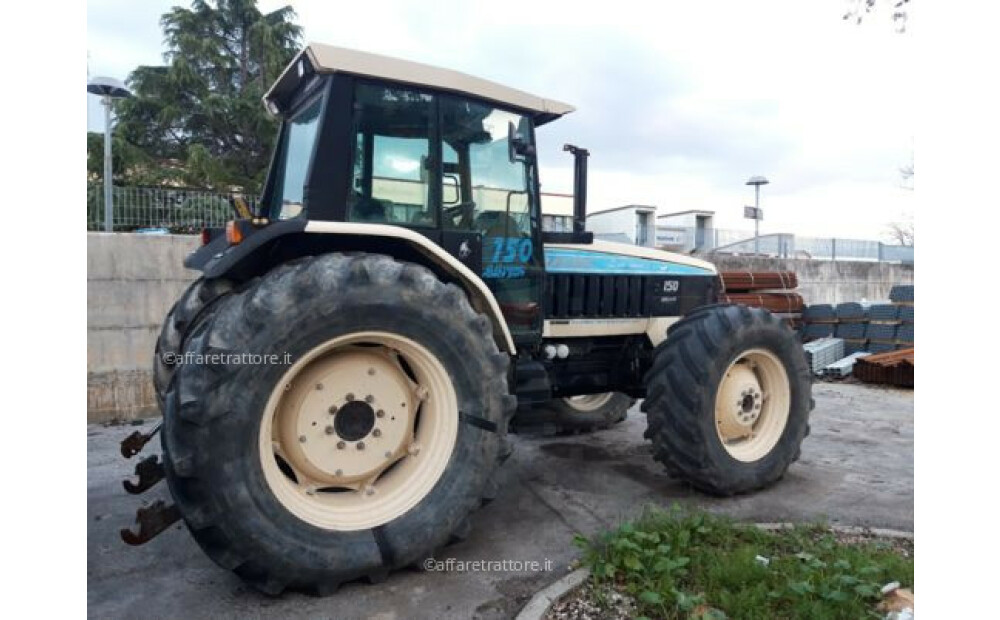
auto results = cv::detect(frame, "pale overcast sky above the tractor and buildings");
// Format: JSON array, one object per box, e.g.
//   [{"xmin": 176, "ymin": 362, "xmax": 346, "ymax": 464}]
[{"xmin": 81, "ymin": 0, "xmax": 916, "ymax": 238}]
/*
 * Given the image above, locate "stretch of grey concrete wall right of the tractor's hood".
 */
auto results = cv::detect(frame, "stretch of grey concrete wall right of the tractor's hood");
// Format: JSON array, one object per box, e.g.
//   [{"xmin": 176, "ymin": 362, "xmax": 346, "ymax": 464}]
[{"xmin": 710, "ymin": 256, "xmax": 913, "ymax": 304}]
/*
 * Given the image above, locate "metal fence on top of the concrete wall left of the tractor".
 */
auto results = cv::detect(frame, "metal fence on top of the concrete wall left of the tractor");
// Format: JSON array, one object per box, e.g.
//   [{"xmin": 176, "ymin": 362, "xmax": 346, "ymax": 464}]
[{"xmin": 87, "ymin": 183, "xmax": 257, "ymax": 233}]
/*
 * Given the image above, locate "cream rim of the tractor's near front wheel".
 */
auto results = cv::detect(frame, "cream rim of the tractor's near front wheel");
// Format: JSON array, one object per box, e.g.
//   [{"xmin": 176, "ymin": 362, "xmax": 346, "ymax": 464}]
[{"xmin": 715, "ymin": 349, "xmax": 791, "ymax": 463}]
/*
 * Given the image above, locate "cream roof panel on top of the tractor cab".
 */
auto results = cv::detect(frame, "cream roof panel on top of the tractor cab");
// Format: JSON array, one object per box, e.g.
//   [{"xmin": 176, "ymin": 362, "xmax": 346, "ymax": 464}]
[{"xmin": 264, "ymin": 43, "xmax": 575, "ymax": 125}]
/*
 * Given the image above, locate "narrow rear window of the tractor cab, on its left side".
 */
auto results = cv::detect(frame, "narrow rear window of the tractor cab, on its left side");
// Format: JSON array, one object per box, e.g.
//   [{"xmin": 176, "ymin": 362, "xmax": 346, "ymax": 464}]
[{"xmin": 271, "ymin": 97, "xmax": 323, "ymax": 220}]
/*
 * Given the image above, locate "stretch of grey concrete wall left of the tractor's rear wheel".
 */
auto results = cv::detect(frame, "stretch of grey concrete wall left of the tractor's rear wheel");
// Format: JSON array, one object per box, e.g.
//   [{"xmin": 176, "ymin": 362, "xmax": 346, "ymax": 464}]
[{"xmin": 87, "ymin": 233, "xmax": 199, "ymax": 422}]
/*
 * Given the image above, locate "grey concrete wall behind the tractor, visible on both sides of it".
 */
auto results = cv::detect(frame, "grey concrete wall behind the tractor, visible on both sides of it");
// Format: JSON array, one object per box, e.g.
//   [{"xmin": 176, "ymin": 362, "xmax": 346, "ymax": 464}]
[{"xmin": 87, "ymin": 234, "xmax": 913, "ymax": 422}]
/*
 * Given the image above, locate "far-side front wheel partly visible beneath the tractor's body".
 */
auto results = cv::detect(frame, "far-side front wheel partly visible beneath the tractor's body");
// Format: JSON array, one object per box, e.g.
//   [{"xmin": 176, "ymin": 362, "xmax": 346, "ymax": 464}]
[{"xmin": 511, "ymin": 392, "xmax": 635, "ymax": 434}]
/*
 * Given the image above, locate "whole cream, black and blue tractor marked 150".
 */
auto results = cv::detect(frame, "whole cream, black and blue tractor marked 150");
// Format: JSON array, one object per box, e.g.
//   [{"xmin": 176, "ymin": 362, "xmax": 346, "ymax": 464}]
[{"xmin": 122, "ymin": 44, "xmax": 813, "ymax": 595}]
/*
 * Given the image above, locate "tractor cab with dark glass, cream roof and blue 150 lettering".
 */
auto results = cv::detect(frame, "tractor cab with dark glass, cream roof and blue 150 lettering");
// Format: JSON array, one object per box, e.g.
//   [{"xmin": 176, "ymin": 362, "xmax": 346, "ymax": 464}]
[{"xmin": 259, "ymin": 45, "xmax": 573, "ymax": 335}]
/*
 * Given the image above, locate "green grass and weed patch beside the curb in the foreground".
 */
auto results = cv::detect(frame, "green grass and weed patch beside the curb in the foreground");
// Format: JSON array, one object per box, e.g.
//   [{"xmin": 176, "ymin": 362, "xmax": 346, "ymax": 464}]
[{"xmin": 575, "ymin": 506, "xmax": 913, "ymax": 620}]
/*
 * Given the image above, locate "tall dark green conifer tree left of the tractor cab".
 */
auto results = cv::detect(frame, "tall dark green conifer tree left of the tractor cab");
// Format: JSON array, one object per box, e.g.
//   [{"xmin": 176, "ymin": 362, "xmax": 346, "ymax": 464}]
[{"xmin": 104, "ymin": 0, "xmax": 301, "ymax": 192}]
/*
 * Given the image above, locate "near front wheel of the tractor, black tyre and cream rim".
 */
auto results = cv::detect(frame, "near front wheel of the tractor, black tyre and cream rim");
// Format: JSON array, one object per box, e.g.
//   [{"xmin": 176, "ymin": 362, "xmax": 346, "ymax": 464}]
[{"xmin": 642, "ymin": 305, "xmax": 813, "ymax": 496}]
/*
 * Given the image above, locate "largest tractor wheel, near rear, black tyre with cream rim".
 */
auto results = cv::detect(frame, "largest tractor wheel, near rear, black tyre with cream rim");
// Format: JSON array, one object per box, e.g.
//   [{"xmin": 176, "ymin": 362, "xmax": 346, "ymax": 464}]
[{"xmin": 162, "ymin": 254, "xmax": 516, "ymax": 594}]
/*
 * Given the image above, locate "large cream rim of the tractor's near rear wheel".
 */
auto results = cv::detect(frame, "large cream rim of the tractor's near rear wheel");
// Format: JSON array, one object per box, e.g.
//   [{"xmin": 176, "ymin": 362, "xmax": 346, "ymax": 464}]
[{"xmin": 260, "ymin": 332, "xmax": 458, "ymax": 531}]
